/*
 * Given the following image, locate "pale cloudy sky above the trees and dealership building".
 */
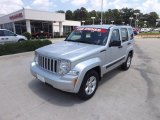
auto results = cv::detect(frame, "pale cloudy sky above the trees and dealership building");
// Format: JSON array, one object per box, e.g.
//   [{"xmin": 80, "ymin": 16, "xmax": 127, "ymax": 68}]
[{"xmin": 0, "ymin": 0, "xmax": 160, "ymax": 15}]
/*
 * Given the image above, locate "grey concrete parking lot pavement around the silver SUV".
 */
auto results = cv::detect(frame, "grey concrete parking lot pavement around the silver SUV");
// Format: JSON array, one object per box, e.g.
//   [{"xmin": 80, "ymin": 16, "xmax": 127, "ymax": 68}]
[{"xmin": 0, "ymin": 39, "xmax": 160, "ymax": 120}]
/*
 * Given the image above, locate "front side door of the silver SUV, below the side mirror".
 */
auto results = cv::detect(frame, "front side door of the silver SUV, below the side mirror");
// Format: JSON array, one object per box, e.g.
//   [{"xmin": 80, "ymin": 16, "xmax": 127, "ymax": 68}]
[{"xmin": 106, "ymin": 28, "xmax": 125, "ymax": 70}]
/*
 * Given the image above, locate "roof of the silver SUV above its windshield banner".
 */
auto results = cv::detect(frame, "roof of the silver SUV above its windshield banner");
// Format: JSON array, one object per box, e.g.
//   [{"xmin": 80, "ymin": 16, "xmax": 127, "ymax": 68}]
[{"xmin": 80, "ymin": 25, "xmax": 132, "ymax": 29}]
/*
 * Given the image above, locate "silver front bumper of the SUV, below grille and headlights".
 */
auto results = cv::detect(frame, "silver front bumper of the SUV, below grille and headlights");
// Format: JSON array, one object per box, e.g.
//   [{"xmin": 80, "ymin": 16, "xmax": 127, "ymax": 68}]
[{"xmin": 30, "ymin": 62, "xmax": 78, "ymax": 92}]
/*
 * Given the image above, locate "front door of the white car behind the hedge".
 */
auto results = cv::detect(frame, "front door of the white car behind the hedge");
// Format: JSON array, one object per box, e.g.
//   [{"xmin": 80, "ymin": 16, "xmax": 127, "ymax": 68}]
[{"xmin": 3, "ymin": 30, "xmax": 17, "ymax": 43}]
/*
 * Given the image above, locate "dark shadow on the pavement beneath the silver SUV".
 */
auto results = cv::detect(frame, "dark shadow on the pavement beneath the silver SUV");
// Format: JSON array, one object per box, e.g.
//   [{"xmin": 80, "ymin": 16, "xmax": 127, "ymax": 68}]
[{"xmin": 28, "ymin": 68, "xmax": 121, "ymax": 107}]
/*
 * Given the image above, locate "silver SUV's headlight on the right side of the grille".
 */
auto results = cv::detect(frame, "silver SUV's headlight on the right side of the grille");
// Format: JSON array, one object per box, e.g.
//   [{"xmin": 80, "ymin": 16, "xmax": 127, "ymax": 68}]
[{"xmin": 58, "ymin": 60, "xmax": 71, "ymax": 75}]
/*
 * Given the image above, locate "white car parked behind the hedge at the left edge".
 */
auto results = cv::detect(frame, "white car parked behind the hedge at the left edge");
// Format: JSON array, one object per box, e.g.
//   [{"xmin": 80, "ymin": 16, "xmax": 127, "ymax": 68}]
[{"xmin": 0, "ymin": 29, "xmax": 27, "ymax": 44}]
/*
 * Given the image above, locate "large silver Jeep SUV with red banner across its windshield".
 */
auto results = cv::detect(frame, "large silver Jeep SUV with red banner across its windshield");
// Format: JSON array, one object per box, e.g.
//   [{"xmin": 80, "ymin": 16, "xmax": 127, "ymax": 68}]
[{"xmin": 30, "ymin": 25, "xmax": 134, "ymax": 100}]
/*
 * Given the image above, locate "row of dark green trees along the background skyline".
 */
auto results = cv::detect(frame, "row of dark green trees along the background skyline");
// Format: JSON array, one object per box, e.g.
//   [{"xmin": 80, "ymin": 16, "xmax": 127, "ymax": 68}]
[{"xmin": 57, "ymin": 7, "xmax": 159, "ymax": 27}]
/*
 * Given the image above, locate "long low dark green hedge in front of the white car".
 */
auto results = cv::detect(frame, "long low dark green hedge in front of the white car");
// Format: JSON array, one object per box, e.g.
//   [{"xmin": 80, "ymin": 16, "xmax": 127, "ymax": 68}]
[{"xmin": 0, "ymin": 40, "xmax": 52, "ymax": 56}]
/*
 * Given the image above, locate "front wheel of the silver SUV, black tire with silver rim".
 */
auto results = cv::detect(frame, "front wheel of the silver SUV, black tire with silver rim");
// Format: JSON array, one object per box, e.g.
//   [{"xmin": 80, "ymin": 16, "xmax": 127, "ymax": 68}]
[{"xmin": 78, "ymin": 70, "xmax": 99, "ymax": 100}]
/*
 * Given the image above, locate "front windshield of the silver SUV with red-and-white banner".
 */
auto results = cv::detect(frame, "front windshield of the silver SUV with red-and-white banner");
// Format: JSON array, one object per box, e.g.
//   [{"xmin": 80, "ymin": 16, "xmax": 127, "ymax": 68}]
[{"xmin": 65, "ymin": 28, "xmax": 109, "ymax": 45}]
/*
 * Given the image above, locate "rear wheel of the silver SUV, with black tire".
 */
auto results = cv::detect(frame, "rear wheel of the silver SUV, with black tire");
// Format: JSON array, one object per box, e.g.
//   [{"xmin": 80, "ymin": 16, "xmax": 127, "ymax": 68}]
[{"xmin": 121, "ymin": 54, "xmax": 132, "ymax": 70}]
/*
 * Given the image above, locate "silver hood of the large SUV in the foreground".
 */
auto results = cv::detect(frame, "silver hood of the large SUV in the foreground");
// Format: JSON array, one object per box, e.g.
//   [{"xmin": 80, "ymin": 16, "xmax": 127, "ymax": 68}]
[{"xmin": 36, "ymin": 41, "xmax": 104, "ymax": 61}]
